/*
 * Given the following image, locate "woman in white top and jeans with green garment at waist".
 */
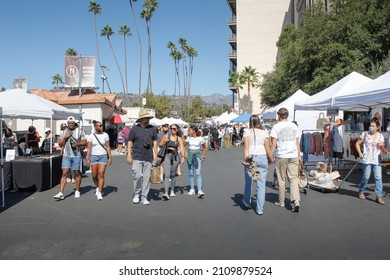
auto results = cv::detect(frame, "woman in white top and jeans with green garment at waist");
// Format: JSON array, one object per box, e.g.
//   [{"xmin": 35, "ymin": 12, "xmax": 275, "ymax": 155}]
[{"xmin": 185, "ymin": 126, "xmax": 207, "ymax": 198}]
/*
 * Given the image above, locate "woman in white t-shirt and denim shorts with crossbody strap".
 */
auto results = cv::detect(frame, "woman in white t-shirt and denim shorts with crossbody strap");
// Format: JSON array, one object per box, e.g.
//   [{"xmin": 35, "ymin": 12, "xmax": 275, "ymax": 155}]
[{"xmin": 86, "ymin": 121, "xmax": 112, "ymax": 200}]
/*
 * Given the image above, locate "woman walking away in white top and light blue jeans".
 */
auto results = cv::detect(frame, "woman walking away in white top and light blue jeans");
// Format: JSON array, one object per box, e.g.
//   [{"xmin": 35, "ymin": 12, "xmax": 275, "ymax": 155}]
[{"xmin": 242, "ymin": 115, "xmax": 272, "ymax": 215}]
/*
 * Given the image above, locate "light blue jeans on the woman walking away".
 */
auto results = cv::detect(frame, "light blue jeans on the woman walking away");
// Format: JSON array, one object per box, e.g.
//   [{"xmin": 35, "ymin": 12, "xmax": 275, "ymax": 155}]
[{"xmin": 243, "ymin": 155, "xmax": 268, "ymax": 213}]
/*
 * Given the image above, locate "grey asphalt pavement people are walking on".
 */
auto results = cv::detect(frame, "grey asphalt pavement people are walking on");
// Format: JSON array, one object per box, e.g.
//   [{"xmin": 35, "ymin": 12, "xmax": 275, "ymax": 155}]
[{"xmin": 0, "ymin": 147, "xmax": 390, "ymax": 260}]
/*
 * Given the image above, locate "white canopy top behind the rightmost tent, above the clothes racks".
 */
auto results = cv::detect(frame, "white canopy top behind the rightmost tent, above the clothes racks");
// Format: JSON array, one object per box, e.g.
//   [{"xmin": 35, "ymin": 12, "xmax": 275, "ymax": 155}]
[{"xmin": 294, "ymin": 72, "xmax": 372, "ymax": 111}]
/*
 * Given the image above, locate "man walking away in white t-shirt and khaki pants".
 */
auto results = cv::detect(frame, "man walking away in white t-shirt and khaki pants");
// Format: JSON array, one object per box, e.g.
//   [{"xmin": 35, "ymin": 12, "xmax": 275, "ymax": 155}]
[{"xmin": 271, "ymin": 108, "xmax": 302, "ymax": 213}]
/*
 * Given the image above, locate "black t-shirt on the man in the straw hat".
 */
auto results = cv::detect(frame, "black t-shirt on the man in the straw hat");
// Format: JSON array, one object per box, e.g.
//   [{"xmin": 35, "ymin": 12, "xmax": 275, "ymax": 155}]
[{"xmin": 129, "ymin": 125, "xmax": 157, "ymax": 162}]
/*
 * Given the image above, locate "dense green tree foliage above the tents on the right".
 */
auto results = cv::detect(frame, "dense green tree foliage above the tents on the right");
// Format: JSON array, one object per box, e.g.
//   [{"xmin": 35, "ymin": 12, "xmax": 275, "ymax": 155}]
[{"xmin": 260, "ymin": 0, "xmax": 390, "ymax": 106}]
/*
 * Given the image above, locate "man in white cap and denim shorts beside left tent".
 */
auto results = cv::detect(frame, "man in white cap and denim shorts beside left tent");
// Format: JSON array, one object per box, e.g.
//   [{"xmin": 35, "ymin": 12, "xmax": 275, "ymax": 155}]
[{"xmin": 53, "ymin": 116, "xmax": 87, "ymax": 200}]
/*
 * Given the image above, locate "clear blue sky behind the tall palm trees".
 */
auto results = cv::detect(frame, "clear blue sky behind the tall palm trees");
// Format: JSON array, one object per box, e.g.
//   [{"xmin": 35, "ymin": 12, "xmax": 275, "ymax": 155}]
[{"xmin": 0, "ymin": 0, "xmax": 231, "ymax": 95}]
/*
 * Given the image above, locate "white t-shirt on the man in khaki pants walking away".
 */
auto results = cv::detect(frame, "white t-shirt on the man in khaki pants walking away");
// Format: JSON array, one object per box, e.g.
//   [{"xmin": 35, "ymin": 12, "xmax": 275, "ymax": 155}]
[{"xmin": 271, "ymin": 121, "xmax": 299, "ymax": 158}]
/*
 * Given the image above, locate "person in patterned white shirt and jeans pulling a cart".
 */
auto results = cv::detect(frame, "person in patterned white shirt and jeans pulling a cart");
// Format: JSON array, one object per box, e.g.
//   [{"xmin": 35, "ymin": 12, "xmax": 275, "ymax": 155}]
[{"xmin": 355, "ymin": 118, "xmax": 385, "ymax": 205}]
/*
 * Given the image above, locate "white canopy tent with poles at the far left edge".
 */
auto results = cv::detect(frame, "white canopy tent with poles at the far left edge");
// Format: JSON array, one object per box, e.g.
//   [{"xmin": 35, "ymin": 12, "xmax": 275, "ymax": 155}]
[{"xmin": 0, "ymin": 89, "xmax": 81, "ymax": 207}]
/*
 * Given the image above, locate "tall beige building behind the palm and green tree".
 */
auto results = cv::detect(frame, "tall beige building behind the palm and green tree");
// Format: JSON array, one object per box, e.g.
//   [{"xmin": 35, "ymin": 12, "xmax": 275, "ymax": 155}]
[{"xmin": 226, "ymin": 0, "xmax": 327, "ymax": 114}]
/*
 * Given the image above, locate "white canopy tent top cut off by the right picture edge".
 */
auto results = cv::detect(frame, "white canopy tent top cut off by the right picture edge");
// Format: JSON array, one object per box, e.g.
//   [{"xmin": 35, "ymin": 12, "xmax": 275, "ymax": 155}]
[{"xmin": 334, "ymin": 71, "xmax": 390, "ymax": 111}]
